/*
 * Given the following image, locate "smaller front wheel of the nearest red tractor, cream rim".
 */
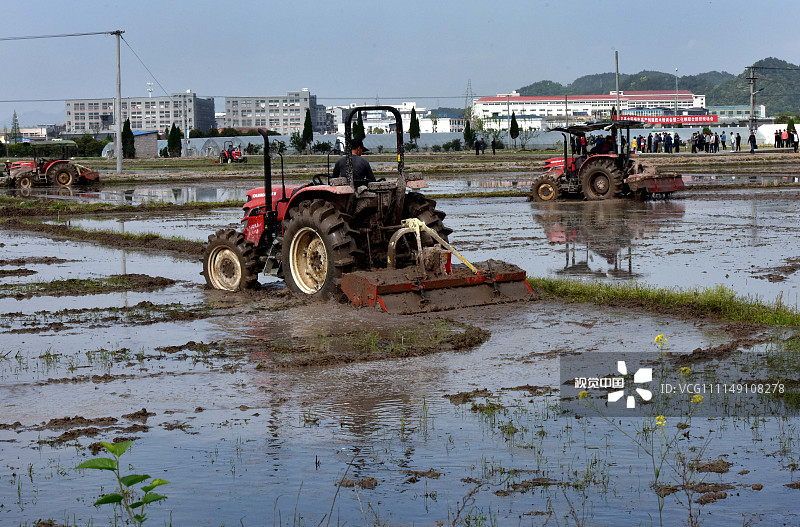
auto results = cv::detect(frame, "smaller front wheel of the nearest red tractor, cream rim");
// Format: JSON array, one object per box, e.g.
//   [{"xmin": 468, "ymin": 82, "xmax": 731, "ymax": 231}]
[{"xmin": 203, "ymin": 229, "xmax": 259, "ymax": 291}]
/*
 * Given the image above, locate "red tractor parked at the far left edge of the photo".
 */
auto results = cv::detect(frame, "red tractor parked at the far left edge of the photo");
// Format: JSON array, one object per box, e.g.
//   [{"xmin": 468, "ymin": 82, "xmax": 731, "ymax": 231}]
[{"xmin": 0, "ymin": 140, "xmax": 100, "ymax": 191}]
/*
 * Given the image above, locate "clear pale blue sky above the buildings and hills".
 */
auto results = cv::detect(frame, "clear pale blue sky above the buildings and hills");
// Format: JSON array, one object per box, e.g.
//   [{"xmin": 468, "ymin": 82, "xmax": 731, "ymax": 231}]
[{"xmin": 0, "ymin": 0, "xmax": 800, "ymax": 127}]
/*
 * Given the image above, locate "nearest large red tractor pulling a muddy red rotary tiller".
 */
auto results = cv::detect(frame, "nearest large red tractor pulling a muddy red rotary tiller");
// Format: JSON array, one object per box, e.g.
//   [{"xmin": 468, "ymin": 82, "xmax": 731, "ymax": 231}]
[{"xmin": 203, "ymin": 106, "xmax": 530, "ymax": 313}]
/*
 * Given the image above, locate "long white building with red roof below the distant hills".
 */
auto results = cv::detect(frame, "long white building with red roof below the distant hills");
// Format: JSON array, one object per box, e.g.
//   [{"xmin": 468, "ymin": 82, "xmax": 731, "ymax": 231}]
[{"xmin": 472, "ymin": 90, "xmax": 706, "ymax": 127}]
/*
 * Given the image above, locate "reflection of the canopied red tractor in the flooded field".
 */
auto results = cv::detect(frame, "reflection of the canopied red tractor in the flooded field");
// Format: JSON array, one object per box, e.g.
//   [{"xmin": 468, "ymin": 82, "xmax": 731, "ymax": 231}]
[{"xmin": 532, "ymin": 201, "xmax": 685, "ymax": 280}]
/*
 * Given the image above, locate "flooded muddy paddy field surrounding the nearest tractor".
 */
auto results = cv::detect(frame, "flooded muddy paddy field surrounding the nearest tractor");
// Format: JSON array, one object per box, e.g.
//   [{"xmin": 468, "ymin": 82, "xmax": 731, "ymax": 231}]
[{"xmin": 0, "ymin": 182, "xmax": 800, "ymax": 526}]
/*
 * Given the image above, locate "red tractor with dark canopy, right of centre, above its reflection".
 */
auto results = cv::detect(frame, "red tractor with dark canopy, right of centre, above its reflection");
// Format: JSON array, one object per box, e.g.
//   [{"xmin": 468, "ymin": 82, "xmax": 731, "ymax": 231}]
[{"xmin": 529, "ymin": 120, "xmax": 684, "ymax": 201}]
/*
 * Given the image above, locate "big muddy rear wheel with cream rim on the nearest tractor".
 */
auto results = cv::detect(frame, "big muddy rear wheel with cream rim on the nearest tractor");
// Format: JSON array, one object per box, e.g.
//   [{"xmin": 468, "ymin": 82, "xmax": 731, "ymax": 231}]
[{"xmin": 281, "ymin": 199, "xmax": 359, "ymax": 298}]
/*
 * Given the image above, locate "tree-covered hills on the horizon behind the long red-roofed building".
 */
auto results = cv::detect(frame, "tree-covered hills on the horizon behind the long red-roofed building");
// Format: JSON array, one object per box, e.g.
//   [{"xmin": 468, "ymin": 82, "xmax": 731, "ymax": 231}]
[{"xmin": 517, "ymin": 57, "xmax": 800, "ymax": 115}]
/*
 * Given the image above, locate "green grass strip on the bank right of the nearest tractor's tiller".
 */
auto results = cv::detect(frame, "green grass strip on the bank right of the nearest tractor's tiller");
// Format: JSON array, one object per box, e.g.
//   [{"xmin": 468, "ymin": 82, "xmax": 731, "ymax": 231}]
[{"xmin": 528, "ymin": 277, "xmax": 800, "ymax": 326}]
